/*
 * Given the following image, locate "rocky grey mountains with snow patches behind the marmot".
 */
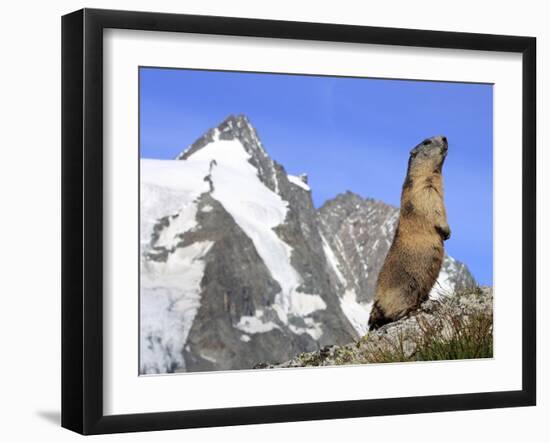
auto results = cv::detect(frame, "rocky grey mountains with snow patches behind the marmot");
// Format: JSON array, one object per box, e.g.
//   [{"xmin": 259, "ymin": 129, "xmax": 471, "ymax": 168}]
[{"xmin": 140, "ymin": 116, "xmax": 474, "ymax": 373}]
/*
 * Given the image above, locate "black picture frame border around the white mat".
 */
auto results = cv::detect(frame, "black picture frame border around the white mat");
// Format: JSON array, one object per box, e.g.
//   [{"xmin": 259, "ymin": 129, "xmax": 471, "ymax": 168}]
[{"xmin": 62, "ymin": 9, "xmax": 536, "ymax": 434}]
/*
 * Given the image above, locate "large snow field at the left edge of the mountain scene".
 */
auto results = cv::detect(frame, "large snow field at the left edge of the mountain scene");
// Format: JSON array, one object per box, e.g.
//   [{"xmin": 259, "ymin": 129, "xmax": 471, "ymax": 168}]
[{"xmin": 140, "ymin": 160, "xmax": 217, "ymax": 374}]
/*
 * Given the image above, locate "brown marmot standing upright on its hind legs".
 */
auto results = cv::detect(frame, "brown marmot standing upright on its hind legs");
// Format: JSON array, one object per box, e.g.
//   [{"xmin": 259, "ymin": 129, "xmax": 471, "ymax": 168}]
[{"xmin": 369, "ymin": 136, "xmax": 451, "ymax": 330}]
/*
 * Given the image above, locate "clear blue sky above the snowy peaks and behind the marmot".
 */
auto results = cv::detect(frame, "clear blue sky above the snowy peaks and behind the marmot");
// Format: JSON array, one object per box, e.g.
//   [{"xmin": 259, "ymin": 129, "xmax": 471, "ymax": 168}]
[{"xmin": 140, "ymin": 68, "xmax": 493, "ymax": 285}]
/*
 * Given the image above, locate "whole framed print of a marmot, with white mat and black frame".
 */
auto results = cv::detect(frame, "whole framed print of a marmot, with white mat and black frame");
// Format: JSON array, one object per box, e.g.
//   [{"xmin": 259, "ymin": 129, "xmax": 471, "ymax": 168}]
[{"xmin": 62, "ymin": 9, "xmax": 536, "ymax": 434}]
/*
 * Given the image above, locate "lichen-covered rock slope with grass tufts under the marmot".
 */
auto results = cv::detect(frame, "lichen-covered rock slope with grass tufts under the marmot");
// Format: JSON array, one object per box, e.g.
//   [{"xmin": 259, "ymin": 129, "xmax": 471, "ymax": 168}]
[{"xmin": 255, "ymin": 287, "xmax": 493, "ymax": 369}]
